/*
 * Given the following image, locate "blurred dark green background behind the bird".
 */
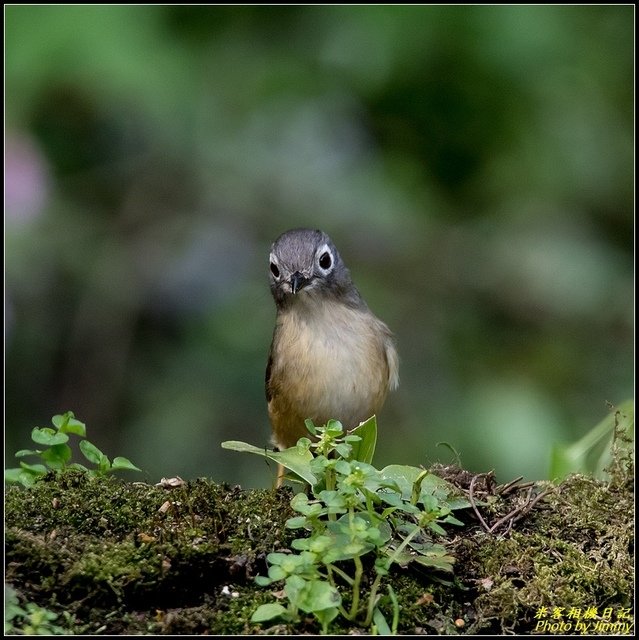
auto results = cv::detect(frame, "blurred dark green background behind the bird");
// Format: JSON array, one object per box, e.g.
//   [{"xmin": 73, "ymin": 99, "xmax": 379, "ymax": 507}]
[{"xmin": 5, "ymin": 5, "xmax": 634, "ymax": 487}]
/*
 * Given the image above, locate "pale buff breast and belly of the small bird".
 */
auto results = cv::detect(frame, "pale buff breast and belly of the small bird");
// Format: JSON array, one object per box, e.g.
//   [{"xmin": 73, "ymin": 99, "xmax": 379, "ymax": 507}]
[{"xmin": 269, "ymin": 303, "xmax": 397, "ymax": 439}]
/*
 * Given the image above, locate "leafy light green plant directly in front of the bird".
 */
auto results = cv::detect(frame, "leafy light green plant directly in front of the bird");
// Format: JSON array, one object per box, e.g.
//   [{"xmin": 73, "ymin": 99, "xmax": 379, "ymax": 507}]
[{"xmin": 222, "ymin": 417, "xmax": 468, "ymax": 634}]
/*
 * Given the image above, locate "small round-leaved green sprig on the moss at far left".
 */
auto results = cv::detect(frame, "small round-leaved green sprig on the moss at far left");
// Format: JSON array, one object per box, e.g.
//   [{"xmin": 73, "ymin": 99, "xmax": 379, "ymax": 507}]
[{"xmin": 4, "ymin": 411, "xmax": 140, "ymax": 487}]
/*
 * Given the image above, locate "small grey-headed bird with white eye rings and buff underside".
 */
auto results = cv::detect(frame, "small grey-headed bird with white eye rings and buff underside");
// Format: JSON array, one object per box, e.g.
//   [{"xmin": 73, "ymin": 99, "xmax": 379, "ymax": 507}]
[{"xmin": 265, "ymin": 228, "xmax": 399, "ymax": 487}]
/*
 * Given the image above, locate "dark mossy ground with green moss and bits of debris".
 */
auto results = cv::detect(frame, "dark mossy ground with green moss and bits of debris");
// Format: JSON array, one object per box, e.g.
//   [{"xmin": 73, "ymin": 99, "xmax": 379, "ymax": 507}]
[{"xmin": 5, "ymin": 458, "xmax": 634, "ymax": 635}]
